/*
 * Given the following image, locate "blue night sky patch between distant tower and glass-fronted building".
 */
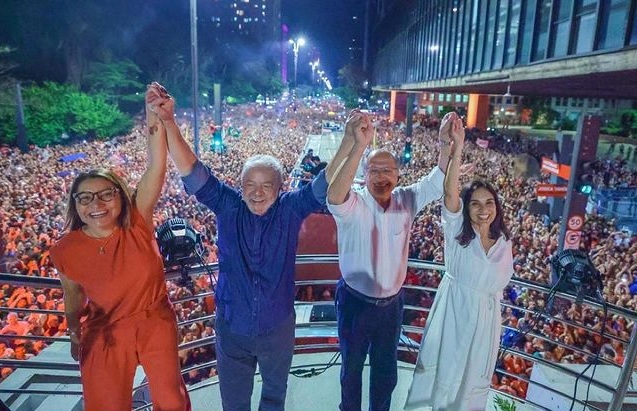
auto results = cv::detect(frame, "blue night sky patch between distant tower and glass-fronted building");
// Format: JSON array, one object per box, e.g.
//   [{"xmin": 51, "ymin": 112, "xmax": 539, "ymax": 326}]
[{"xmin": 281, "ymin": 0, "xmax": 365, "ymax": 82}]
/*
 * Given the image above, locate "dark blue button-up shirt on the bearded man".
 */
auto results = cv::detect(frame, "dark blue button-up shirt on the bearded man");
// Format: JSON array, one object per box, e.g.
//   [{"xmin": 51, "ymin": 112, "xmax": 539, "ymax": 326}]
[{"xmin": 182, "ymin": 162, "xmax": 327, "ymax": 336}]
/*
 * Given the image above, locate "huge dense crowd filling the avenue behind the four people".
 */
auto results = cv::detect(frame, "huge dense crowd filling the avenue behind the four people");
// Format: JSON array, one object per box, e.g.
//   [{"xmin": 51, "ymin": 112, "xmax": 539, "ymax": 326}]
[{"xmin": 0, "ymin": 96, "xmax": 637, "ymax": 406}]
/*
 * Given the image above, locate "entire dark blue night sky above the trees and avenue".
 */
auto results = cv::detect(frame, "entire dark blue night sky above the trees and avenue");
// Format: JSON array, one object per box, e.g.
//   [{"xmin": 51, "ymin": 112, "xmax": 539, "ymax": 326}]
[{"xmin": 0, "ymin": 0, "xmax": 365, "ymax": 85}]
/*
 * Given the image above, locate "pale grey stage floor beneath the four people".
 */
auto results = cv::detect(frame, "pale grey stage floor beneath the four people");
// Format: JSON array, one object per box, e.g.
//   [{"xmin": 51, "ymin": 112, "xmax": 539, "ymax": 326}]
[{"xmin": 0, "ymin": 343, "xmax": 538, "ymax": 411}]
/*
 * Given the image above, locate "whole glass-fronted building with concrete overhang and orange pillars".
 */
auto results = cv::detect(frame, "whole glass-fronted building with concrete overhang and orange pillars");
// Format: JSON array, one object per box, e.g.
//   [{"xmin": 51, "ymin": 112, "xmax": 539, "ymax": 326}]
[{"xmin": 370, "ymin": 0, "xmax": 637, "ymax": 128}]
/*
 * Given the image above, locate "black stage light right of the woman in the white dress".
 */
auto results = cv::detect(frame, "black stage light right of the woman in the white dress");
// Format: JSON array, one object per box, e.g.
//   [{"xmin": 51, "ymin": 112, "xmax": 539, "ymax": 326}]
[{"xmin": 551, "ymin": 250, "xmax": 604, "ymax": 303}]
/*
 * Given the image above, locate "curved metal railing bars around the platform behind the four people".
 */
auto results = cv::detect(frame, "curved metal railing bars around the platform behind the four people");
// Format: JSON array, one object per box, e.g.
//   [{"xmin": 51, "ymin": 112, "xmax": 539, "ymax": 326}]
[{"xmin": 0, "ymin": 255, "xmax": 637, "ymax": 411}]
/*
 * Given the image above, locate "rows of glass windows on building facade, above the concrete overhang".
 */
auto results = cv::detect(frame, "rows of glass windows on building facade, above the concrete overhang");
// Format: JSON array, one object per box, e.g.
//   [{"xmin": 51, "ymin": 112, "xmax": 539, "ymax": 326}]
[{"xmin": 372, "ymin": 0, "xmax": 637, "ymax": 88}]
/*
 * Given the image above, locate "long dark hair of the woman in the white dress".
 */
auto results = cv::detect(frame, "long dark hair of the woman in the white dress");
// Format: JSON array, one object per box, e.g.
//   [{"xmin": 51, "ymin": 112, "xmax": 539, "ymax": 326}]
[{"xmin": 456, "ymin": 180, "xmax": 511, "ymax": 247}]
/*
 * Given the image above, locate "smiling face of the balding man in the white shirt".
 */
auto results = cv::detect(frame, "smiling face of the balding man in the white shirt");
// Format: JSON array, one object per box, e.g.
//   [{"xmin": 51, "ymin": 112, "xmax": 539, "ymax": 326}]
[{"xmin": 365, "ymin": 151, "xmax": 398, "ymax": 204}]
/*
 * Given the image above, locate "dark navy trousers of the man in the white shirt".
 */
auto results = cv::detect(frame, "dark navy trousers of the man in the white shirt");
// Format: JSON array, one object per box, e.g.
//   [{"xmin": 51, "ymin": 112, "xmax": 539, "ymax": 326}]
[{"xmin": 336, "ymin": 280, "xmax": 404, "ymax": 411}]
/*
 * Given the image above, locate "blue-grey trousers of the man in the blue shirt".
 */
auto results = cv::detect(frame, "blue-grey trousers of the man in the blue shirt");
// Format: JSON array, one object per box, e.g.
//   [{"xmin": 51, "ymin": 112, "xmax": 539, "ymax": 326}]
[{"xmin": 216, "ymin": 314, "xmax": 295, "ymax": 411}]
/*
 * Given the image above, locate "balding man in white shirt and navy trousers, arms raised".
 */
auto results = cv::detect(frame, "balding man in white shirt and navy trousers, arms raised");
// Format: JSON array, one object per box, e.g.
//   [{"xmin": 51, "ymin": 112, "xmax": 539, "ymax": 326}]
[{"xmin": 328, "ymin": 113, "xmax": 450, "ymax": 411}]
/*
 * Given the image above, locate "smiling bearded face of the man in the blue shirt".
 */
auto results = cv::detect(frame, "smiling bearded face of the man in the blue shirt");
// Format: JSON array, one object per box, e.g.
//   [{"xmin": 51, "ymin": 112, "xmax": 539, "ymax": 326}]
[{"xmin": 241, "ymin": 165, "xmax": 281, "ymax": 216}]
